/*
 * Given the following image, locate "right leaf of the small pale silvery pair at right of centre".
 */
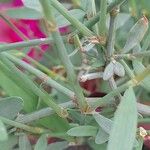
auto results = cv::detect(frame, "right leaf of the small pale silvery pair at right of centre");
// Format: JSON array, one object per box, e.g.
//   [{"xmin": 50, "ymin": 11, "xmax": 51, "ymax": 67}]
[{"xmin": 114, "ymin": 62, "xmax": 125, "ymax": 77}]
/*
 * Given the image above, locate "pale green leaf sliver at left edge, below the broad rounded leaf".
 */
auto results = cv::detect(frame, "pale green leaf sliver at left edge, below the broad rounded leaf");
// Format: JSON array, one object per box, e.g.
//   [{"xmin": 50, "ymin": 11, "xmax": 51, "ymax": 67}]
[{"xmin": 0, "ymin": 120, "xmax": 8, "ymax": 141}]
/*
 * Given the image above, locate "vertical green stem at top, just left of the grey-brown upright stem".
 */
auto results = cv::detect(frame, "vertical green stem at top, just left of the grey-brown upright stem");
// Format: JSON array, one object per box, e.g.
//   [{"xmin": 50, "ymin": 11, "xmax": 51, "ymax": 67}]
[{"xmin": 99, "ymin": 0, "xmax": 107, "ymax": 37}]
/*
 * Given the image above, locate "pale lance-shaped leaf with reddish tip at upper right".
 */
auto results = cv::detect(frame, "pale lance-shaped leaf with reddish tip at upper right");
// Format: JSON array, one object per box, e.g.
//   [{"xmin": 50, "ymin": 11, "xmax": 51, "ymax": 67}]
[{"xmin": 122, "ymin": 16, "xmax": 148, "ymax": 53}]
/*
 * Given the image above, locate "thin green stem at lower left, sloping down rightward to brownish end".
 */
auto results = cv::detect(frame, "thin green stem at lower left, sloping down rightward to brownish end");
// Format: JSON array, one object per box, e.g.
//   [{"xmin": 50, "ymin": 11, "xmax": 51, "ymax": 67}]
[{"xmin": 0, "ymin": 116, "xmax": 48, "ymax": 134}]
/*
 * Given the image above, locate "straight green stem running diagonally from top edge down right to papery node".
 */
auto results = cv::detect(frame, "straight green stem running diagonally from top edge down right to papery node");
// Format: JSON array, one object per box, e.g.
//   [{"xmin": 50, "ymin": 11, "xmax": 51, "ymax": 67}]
[{"xmin": 50, "ymin": 0, "xmax": 94, "ymax": 37}]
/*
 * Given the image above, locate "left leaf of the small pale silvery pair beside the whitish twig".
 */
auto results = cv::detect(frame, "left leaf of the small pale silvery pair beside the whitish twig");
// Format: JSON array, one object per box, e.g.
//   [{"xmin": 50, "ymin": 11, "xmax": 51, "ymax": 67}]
[{"xmin": 103, "ymin": 62, "xmax": 114, "ymax": 80}]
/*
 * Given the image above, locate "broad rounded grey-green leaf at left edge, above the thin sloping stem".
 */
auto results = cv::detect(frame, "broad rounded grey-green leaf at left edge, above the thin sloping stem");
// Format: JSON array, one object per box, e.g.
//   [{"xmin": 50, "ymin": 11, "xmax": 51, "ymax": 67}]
[{"xmin": 0, "ymin": 97, "xmax": 23, "ymax": 120}]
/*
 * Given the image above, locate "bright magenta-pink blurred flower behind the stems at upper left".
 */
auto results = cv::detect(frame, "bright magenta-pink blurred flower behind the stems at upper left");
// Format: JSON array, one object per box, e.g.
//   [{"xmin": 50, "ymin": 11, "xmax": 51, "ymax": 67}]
[{"xmin": 0, "ymin": 0, "xmax": 68, "ymax": 60}]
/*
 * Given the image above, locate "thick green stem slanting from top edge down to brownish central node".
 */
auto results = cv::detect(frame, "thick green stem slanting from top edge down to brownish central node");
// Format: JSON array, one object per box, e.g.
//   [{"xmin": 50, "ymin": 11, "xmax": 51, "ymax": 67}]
[{"xmin": 40, "ymin": 0, "xmax": 88, "ymax": 112}]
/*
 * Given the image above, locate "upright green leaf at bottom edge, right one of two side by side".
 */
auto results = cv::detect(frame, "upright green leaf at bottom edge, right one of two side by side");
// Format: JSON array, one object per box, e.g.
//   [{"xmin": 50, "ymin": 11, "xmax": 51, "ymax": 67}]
[{"xmin": 34, "ymin": 135, "xmax": 47, "ymax": 150}]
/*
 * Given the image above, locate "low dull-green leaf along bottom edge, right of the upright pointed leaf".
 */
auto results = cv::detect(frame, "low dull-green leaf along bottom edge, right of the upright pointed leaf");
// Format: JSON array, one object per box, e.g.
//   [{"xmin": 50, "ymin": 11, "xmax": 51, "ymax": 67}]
[{"xmin": 46, "ymin": 141, "xmax": 68, "ymax": 150}]
